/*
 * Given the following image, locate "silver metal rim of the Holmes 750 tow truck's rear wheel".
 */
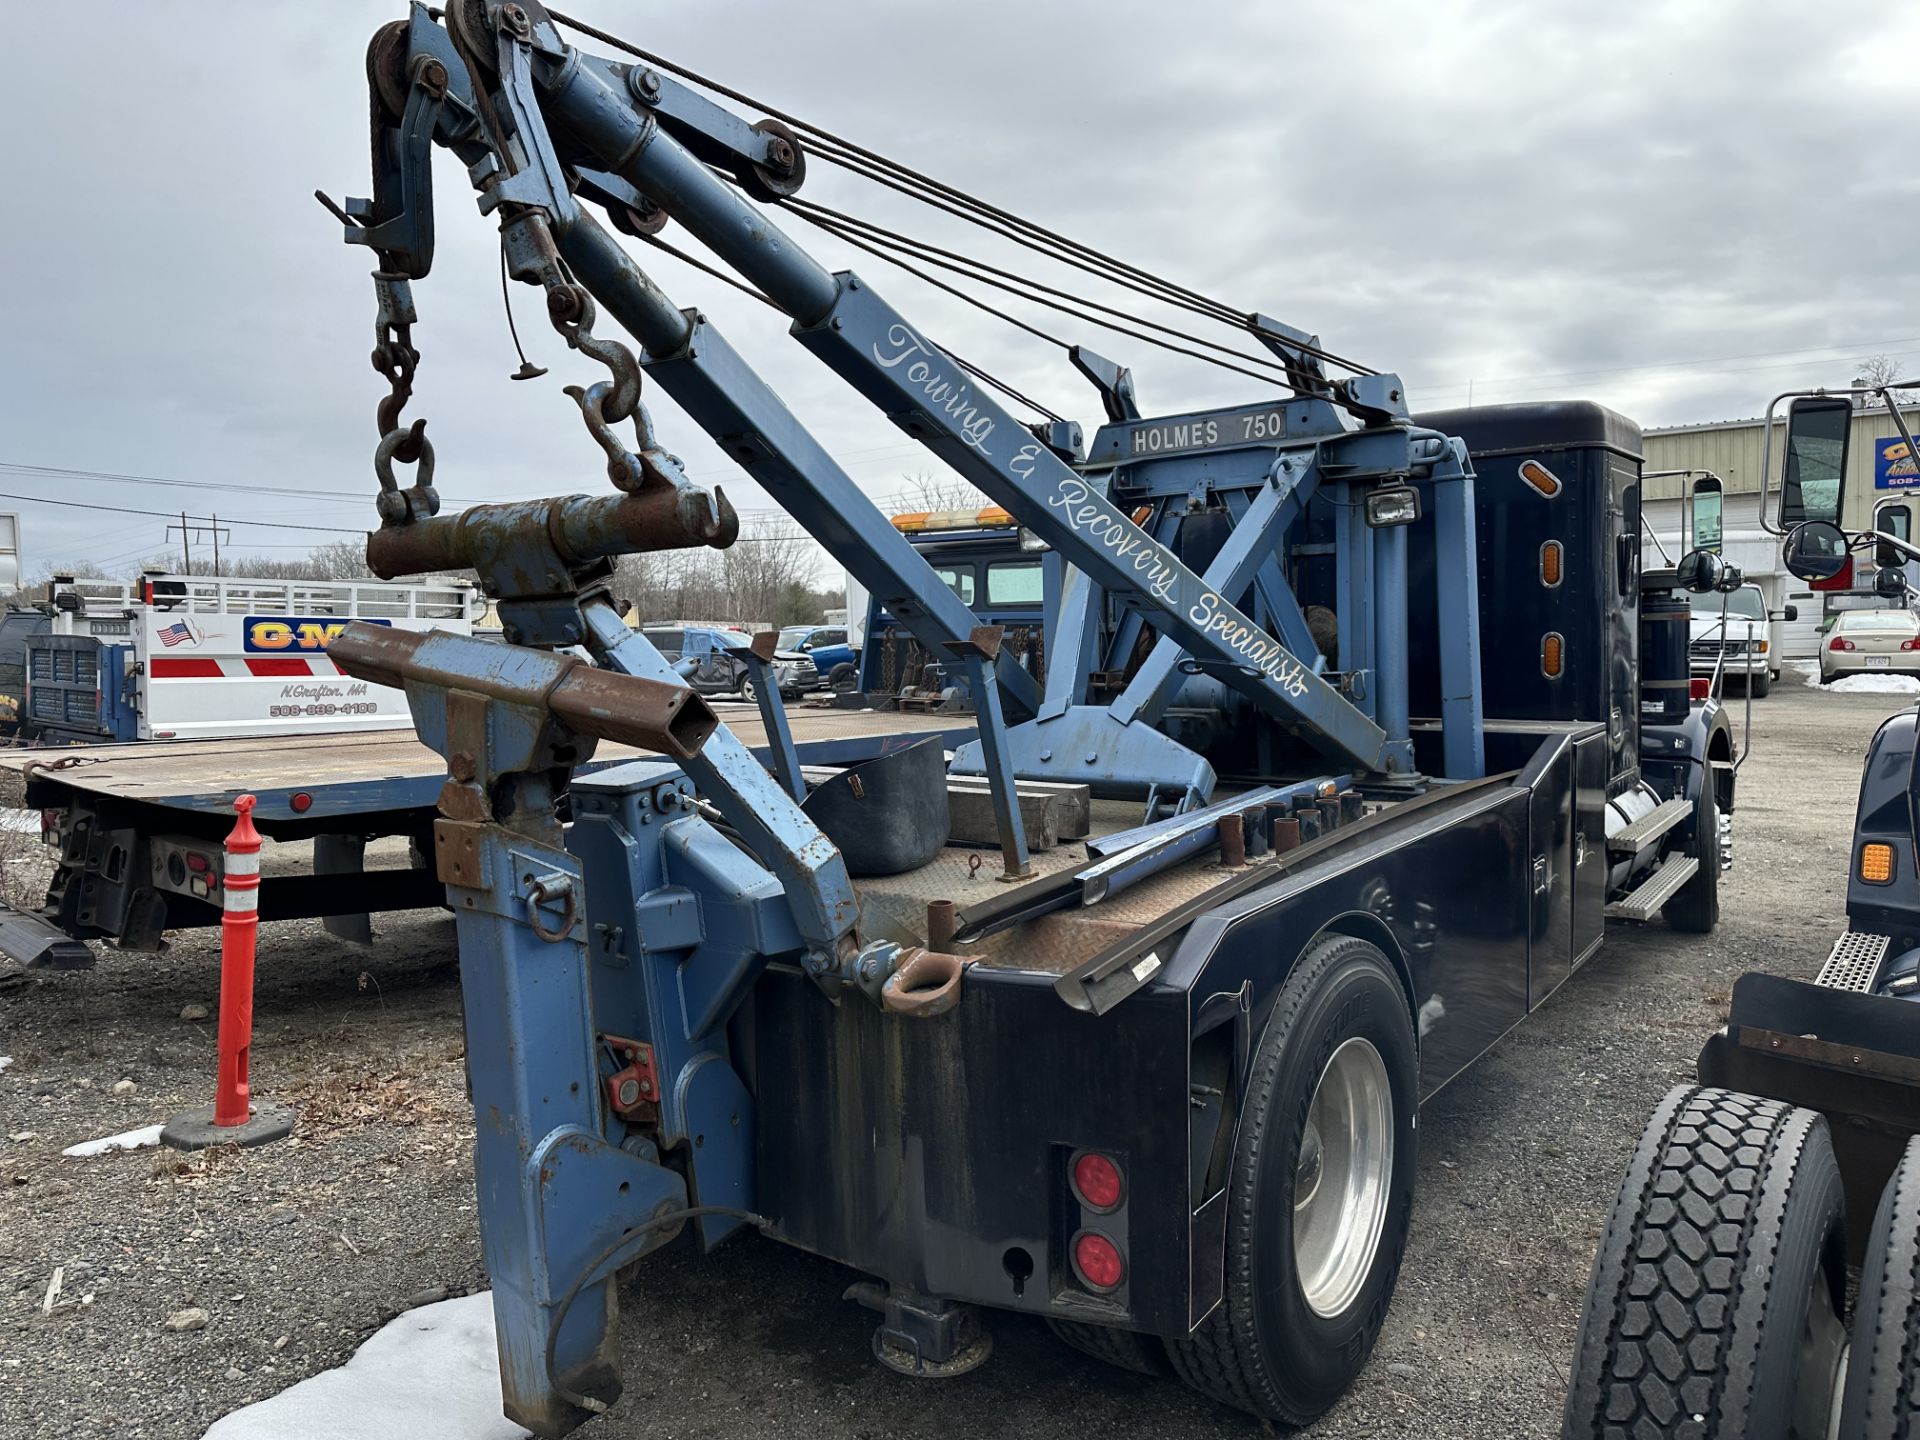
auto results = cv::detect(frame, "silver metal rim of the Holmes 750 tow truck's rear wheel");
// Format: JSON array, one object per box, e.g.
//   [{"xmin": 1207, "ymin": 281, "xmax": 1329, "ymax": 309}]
[{"xmin": 1294, "ymin": 1035, "xmax": 1394, "ymax": 1319}]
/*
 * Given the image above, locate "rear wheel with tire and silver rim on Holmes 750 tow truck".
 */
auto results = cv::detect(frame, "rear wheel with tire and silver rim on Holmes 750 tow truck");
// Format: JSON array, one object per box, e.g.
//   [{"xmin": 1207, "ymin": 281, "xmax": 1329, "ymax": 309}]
[{"xmin": 1167, "ymin": 935, "xmax": 1417, "ymax": 1425}]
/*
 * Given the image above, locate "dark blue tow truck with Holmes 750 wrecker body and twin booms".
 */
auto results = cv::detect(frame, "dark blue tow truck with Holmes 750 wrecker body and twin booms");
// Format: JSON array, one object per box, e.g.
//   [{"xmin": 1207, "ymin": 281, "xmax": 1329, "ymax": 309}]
[{"xmin": 0, "ymin": 0, "xmax": 1734, "ymax": 1436}]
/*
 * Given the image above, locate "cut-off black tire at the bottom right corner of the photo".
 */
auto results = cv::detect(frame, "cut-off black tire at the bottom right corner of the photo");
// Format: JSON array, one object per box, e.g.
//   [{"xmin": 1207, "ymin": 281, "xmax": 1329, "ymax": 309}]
[{"xmin": 1839, "ymin": 1140, "xmax": 1920, "ymax": 1440}]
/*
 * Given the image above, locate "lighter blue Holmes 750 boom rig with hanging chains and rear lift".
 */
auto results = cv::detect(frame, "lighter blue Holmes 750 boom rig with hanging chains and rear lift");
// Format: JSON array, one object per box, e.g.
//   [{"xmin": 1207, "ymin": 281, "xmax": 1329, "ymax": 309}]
[{"xmin": 323, "ymin": 0, "xmax": 1484, "ymax": 1434}]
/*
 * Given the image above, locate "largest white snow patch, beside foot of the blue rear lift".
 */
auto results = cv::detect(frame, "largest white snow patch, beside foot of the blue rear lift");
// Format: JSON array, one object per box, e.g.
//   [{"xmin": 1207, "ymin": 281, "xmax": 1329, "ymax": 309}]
[{"xmin": 204, "ymin": 1290, "xmax": 526, "ymax": 1440}]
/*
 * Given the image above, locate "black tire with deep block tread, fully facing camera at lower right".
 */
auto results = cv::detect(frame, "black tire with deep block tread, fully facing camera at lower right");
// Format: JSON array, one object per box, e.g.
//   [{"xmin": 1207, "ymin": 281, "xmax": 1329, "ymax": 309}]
[{"xmin": 1561, "ymin": 1085, "xmax": 1847, "ymax": 1440}]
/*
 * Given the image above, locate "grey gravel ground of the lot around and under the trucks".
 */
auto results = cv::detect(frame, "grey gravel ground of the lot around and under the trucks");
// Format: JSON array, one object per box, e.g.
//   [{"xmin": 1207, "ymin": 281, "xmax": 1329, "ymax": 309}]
[{"xmin": 0, "ymin": 674, "xmax": 1907, "ymax": 1440}]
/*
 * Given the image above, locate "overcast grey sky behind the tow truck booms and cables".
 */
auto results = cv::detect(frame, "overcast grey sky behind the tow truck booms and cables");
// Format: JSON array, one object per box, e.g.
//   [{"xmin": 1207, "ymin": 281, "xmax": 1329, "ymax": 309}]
[{"xmin": 0, "ymin": 0, "xmax": 1920, "ymax": 578}]
